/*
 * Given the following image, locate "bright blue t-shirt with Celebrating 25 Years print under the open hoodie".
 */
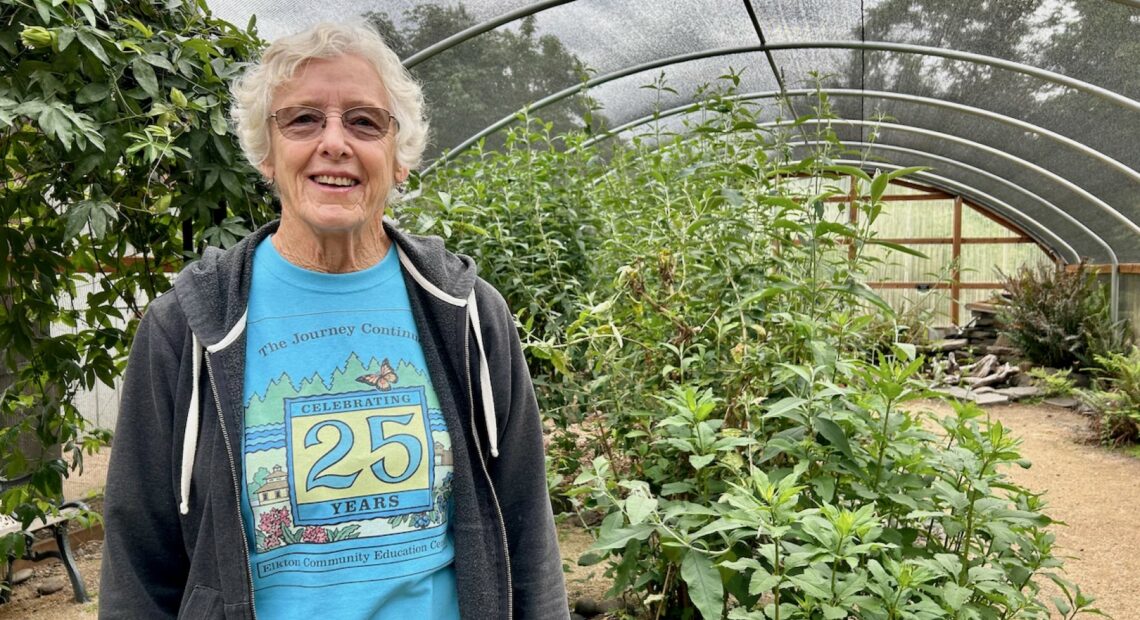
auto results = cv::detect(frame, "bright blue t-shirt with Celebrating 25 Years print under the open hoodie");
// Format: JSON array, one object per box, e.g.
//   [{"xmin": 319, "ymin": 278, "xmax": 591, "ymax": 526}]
[{"xmin": 242, "ymin": 239, "xmax": 458, "ymax": 619}]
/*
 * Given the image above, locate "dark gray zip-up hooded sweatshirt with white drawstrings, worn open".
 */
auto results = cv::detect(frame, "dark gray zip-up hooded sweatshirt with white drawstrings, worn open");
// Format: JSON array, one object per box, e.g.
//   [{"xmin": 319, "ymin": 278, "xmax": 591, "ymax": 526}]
[{"xmin": 99, "ymin": 220, "xmax": 569, "ymax": 620}]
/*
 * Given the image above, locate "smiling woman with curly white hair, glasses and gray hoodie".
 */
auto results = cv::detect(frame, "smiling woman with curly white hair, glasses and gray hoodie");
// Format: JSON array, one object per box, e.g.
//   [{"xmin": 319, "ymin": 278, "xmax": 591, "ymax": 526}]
[{"xmin": 99, "ymin": 25, "xmax": 569, "ymax": 620}]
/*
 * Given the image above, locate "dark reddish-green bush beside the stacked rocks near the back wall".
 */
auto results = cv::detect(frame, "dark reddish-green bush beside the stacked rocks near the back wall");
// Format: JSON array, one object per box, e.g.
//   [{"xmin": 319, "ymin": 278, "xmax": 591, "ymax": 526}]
[{"xmin": 1000, "ymin": 263, "xmax": 1131, "ymax": 368}]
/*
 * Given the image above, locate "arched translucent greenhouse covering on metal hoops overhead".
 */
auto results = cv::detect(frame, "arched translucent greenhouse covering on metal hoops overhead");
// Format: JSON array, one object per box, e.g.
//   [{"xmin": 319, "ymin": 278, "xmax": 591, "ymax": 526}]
[{"xmin": 210, "ymin": 0, "xmax": 1140, "ymax": 264}]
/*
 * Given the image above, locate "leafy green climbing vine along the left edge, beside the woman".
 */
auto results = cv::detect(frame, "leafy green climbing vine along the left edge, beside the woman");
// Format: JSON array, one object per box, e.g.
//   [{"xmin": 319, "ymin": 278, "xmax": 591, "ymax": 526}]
[{"xmin": 0, "ymin": 0, "xmax": 270, "ymax": 557}]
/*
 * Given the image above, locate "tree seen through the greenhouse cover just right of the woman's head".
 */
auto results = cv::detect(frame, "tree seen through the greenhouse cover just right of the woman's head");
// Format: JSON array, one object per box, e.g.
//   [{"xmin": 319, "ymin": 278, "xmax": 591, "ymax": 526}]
[{"xmin": 365, "ymin": 5, "xmax": 588, "ymax": 154}]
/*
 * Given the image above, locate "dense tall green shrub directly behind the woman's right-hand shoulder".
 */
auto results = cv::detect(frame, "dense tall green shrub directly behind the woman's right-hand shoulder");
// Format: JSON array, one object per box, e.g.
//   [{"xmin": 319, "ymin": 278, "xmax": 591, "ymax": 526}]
[{"xmin": 403, "ymin": 114, "xmax": 602, "ymax": 419}]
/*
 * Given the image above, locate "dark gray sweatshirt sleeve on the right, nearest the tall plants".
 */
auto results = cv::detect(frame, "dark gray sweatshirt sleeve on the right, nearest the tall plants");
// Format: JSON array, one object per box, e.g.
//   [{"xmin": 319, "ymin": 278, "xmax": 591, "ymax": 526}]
[{"xmin": 480, "ymin": 283, "xmax": 570, "ymax": 620}]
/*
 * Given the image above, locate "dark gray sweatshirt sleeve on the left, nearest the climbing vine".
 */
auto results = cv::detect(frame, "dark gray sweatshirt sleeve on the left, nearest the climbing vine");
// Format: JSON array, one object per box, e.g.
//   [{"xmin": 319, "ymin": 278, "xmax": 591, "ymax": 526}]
[{"xmin": 99, "ymin": 295, "xmax": 189, "ymax": 620}]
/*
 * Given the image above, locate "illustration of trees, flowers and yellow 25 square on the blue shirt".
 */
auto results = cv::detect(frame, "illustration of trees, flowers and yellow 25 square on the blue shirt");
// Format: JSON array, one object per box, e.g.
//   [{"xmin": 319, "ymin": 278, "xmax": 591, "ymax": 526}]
[{"xmin": 243, "ymin": 353, "xmax": 453, "ymax": 553}]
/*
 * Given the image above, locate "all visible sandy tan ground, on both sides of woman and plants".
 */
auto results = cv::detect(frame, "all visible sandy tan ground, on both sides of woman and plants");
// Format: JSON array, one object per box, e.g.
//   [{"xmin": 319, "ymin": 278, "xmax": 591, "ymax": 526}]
[{"xmin": 0, "ymin": 402, "xmax": 1140, "ymax": 620}]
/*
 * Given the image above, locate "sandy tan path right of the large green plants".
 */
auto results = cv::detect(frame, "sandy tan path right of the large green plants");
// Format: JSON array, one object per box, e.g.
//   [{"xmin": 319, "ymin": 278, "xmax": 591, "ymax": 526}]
[{"xmin": 916, "ymin": 403, "xmax": 1140, "ymax": 620}]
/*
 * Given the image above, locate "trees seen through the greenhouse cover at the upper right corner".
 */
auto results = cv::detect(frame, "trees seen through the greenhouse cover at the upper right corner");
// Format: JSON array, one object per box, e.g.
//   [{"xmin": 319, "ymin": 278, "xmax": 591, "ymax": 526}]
[{"xmin": 839, "ymin": 0, "xmax": 1140, "ymax": 162}]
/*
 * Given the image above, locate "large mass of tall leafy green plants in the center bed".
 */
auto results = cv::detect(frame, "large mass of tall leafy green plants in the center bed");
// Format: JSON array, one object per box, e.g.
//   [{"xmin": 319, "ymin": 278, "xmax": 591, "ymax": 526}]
[{"xmin": 419, "ymin": 74, "xmax": 1088, "ymax": 619}]
